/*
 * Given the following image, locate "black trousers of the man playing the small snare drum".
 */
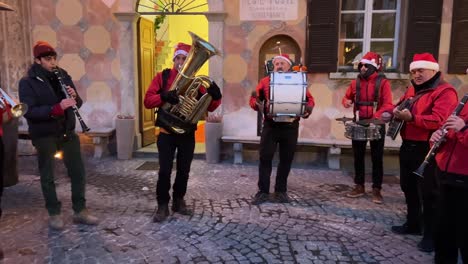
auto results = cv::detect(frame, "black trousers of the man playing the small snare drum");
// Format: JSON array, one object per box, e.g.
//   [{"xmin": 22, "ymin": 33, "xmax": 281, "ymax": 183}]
[{"xmin": 352, "ymin": 126, "xmax": 385, "ymax": 189}]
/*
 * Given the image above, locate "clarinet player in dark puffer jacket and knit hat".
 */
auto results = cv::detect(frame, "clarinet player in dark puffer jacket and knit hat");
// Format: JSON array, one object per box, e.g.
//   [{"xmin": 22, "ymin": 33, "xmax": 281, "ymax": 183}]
[{"xmin": 19, "ymin": 41, "xmax": 98, "ymax": 230}]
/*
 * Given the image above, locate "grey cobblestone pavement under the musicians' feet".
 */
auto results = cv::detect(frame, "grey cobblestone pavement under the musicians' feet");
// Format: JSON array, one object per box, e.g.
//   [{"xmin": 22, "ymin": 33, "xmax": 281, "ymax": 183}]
[{"xmin": 0, "ymin": 156, "xmax": 433, "ymax": 264}]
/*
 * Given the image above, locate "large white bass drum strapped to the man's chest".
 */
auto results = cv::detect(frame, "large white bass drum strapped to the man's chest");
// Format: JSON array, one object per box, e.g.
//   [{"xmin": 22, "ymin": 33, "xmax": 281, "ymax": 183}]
[{"xmin": 269, "ymin": 72, "xmax": 307, "ymax": 117}]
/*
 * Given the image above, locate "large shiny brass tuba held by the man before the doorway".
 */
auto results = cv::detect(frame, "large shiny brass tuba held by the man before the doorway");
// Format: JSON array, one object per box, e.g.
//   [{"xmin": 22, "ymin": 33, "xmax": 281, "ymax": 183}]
[{"xmin": 156, "ymin": 31, "xmax": 220, "ymax": 134}]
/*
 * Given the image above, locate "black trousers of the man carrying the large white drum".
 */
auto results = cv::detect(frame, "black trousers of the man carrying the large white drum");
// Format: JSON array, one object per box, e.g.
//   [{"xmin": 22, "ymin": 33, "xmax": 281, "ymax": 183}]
[{"xmin": 258, "ymin": 120, "xmax": 299, "ymax": 193}]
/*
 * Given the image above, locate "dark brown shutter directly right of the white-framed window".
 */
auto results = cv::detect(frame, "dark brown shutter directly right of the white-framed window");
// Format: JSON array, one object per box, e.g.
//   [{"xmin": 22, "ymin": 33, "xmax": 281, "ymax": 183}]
[{"xmin": 403, "ymin": 0, "xmax": 442, "ymax": 72}]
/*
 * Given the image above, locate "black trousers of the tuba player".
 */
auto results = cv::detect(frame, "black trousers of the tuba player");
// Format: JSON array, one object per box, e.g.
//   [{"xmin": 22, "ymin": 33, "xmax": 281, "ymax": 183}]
[{"xmin": 156, "ymin": 132, "xmax": 195, "ymax": 204}]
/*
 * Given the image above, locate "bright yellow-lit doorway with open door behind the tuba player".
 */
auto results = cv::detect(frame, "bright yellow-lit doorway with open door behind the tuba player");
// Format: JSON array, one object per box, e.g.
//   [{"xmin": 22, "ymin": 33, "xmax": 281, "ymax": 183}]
[{"xmin": 136, "ymin": 0, "xmax": 208, "ymax": 146}]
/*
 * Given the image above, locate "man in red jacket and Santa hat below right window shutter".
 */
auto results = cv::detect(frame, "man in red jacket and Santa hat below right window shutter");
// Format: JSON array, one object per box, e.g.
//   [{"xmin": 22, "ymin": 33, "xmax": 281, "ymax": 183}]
[{"xmin": 392, "ymin": 53, "xmax": 458, "ymax": 252}]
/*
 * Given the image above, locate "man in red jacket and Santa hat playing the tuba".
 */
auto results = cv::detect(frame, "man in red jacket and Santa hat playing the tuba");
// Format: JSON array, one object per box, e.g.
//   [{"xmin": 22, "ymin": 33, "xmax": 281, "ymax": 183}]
[{"xmin": 144, "ymin": 43, "xmax": 222, "ymax": 222}]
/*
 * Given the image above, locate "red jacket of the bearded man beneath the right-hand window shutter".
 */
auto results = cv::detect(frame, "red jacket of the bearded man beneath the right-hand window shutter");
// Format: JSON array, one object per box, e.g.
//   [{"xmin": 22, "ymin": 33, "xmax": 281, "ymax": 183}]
[{"xmin": 400, "ymin": 81, "xmax": 458, "ymax": 141}]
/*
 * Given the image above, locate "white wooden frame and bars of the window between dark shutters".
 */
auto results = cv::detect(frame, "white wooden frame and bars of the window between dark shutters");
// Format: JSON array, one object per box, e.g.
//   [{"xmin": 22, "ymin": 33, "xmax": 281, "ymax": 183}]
[{"xmin": 338, "ymin": 0, "xmax": 401, "ymax": 70}]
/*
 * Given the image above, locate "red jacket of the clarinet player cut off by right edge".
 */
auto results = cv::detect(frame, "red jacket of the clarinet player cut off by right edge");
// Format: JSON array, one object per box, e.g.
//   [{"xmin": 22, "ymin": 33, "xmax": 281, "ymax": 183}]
[{"xmin": 435, "ymin": 106, "xmax": 468, "ymax": 177}]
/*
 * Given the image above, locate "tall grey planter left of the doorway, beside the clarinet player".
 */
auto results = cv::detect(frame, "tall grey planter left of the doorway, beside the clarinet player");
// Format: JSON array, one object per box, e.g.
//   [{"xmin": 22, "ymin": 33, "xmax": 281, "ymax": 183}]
[{"xmin": 115, "ymin": 114, "xmax": 135, "ymax": 159}]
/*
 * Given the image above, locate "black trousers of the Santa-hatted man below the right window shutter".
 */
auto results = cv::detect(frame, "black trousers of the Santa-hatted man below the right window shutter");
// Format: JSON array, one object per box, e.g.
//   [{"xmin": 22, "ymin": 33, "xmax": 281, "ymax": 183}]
[{"xmin": 400, "ymin": 140, "xmax": 438, "ymax": 239}]
